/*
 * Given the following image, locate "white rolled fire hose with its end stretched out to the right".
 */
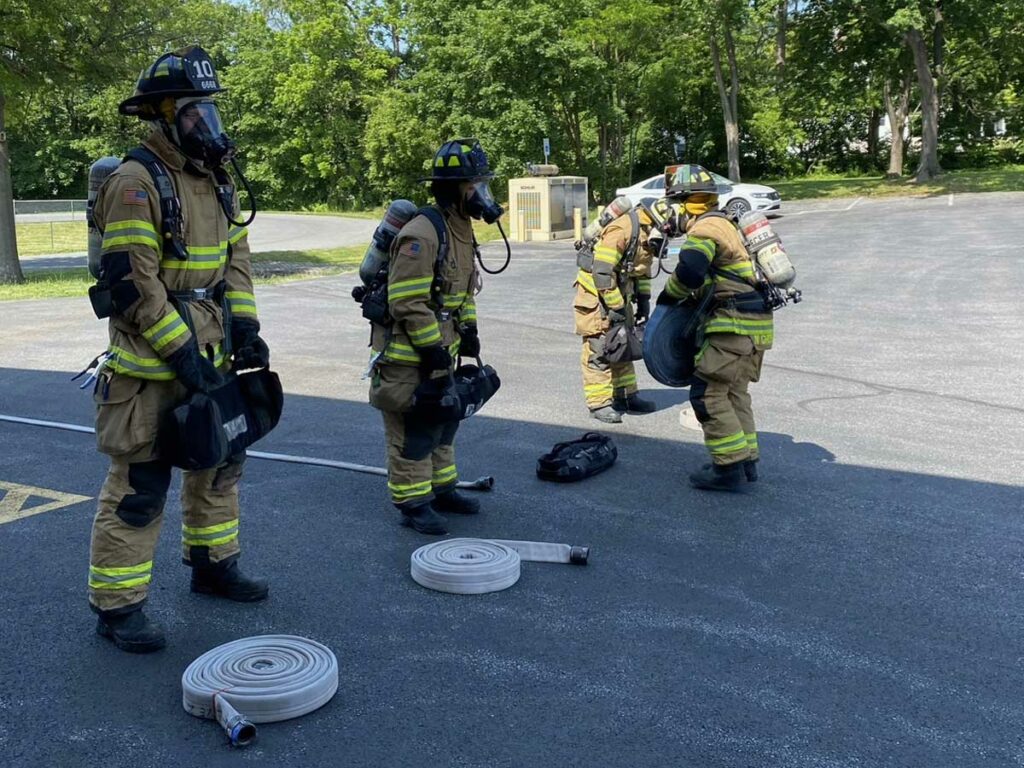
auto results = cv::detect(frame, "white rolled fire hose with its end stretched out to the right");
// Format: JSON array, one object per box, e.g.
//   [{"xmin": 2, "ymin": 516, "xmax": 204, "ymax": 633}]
[{"xmin": 410, "ymin": 539, "xmax": 590, "ymax": 595}]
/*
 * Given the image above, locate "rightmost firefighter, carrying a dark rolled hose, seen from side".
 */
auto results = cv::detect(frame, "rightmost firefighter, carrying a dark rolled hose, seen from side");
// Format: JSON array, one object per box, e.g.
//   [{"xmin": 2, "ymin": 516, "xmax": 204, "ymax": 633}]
[{"xmin": 657, "ymin": 165, "xmax": 773, "ymax": 489}]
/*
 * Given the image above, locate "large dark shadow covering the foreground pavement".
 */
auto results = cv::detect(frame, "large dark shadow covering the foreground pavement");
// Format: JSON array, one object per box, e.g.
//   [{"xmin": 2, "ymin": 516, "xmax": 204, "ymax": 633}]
[{"xmin": 0, "ymin": 369, "xmax": 1024, "ymax": 767}]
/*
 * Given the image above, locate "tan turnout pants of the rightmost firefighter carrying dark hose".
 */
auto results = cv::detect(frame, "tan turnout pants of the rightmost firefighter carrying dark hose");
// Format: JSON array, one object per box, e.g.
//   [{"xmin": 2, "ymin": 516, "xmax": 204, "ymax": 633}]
[{"xmin": 690, "ymin": 334, "xmax": 764, "ymax": 466}]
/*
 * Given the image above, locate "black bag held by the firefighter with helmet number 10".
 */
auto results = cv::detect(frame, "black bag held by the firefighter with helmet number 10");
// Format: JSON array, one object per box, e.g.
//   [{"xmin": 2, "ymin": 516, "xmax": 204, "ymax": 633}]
[{"xmin": 158, "ymin": 369, "xmax": 285, "ymax": 470}]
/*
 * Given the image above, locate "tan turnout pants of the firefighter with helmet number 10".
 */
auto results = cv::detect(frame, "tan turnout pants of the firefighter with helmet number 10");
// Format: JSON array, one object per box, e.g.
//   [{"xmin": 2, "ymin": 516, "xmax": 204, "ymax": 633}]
[{"xmin": 89, "ymin": 375, "xmax": 245, "ymax": 612}]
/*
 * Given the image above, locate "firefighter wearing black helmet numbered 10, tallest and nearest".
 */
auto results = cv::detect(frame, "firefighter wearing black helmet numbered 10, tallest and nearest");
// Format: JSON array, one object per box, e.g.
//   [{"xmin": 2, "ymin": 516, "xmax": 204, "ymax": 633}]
[{"xmin": 89, "ymin": 47, "xmax": 269, "ymax": 652}]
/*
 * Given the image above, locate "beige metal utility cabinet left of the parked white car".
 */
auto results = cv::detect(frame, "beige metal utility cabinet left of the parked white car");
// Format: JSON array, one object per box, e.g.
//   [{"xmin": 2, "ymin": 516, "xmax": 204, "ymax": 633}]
[{"xmin": 509, "ymin": 174, "xmax": 588, "ymax": 243}]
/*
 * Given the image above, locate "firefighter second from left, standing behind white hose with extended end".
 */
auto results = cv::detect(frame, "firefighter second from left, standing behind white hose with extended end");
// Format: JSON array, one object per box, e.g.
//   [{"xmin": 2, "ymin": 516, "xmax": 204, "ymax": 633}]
[{"xmin": 370, "ymin": 138, "xmax": 502, "ymax": 535}]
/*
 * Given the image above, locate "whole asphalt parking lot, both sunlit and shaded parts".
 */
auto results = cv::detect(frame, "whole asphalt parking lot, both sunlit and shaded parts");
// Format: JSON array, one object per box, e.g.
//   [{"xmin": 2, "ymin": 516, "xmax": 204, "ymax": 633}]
[{"xmin": 0, "ymin": 194, "xmax": 1024, "ymax": 768}]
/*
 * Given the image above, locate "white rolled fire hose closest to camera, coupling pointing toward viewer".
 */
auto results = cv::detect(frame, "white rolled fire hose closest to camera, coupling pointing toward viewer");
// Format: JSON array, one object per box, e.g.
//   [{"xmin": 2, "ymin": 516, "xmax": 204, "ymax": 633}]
[{"xmin": 181, "ymin": 635, "xmax": 338, "ymax": 746}]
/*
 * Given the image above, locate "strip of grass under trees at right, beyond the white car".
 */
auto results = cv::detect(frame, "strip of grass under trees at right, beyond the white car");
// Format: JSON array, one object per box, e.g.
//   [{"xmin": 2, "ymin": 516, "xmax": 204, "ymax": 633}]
[{"xmin": 764, "ymin": 165, "xmax": 1024, "ymax": 201}]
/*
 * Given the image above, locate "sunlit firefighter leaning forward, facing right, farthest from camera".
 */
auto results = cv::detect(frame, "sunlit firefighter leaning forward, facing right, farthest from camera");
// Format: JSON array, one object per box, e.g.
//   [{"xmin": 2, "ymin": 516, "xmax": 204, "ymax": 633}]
[{"xmin": 572, "ymin": 207, "xmax": 656, "ymax": 424}]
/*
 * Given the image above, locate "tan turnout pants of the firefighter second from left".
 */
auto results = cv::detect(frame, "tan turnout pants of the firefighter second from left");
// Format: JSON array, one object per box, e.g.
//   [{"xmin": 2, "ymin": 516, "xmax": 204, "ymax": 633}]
[{"xmin": 370, "ymin": 364, "xmax": 459, "ymax": 509}]
